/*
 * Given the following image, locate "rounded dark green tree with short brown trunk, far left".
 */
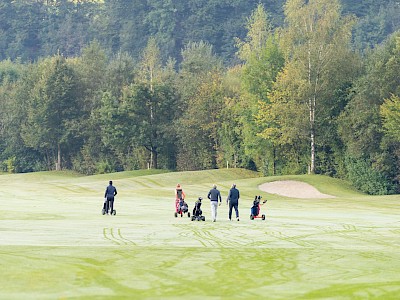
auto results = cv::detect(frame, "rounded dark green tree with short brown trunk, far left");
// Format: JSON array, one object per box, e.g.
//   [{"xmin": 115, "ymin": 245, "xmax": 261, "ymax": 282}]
[{"xmin": 21, "ymin": 56, "xmax": 81, "ymax": 169}]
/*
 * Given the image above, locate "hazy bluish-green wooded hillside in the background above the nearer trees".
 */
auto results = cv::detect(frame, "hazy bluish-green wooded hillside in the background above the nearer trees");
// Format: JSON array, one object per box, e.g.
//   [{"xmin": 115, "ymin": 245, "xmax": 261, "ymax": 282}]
[{"xmin": 0, "ymin": 0, "xmax": 400, "ymax": 66}]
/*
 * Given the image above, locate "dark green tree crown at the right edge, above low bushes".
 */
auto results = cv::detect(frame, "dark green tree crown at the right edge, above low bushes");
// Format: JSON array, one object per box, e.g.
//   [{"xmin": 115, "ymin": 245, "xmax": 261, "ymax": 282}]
[{"xmin": 338, "ymin": 34, "xmax": 400, "ymax": 176}]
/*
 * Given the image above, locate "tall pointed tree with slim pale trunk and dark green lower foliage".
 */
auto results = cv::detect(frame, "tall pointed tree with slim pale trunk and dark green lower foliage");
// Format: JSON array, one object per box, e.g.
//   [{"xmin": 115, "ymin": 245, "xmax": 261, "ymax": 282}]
[{"xmin": 134, "ymin": 38, "xmax": 177, "ymax": 169}]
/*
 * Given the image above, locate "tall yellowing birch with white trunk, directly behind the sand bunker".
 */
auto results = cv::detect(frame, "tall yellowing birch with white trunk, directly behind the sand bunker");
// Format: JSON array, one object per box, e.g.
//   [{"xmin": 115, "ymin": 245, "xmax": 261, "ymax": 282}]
[{"xmin": 265, "ymin": 0, "xmax": 354, "ymax": 173}]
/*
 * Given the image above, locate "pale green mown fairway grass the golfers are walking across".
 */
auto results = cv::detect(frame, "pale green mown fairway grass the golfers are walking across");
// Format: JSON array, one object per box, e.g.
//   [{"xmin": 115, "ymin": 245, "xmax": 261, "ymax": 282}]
[{"xmin": 0, "ymin": 170, "xmax": 400, "ymax": 299}]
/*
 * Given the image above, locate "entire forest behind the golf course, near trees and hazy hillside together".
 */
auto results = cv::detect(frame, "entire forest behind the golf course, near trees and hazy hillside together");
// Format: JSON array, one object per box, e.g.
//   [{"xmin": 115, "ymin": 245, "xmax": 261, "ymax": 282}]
[{"xmin": 0, "ymin": 0, "xmax": 400, "ymax": 194}]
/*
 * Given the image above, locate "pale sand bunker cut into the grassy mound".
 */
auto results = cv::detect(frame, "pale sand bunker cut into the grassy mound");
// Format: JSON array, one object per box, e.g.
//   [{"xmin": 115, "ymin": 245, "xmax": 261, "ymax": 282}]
[{"xmin": 258, "ymin": 180, "xmax": 335, "ymax": 199}]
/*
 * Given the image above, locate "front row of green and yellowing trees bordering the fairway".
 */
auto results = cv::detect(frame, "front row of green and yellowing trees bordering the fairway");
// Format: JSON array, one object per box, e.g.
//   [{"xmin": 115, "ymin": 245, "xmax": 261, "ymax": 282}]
[{"xmin": 0, "ymin": 0, "xmax": 400, "ymax": 194}]
